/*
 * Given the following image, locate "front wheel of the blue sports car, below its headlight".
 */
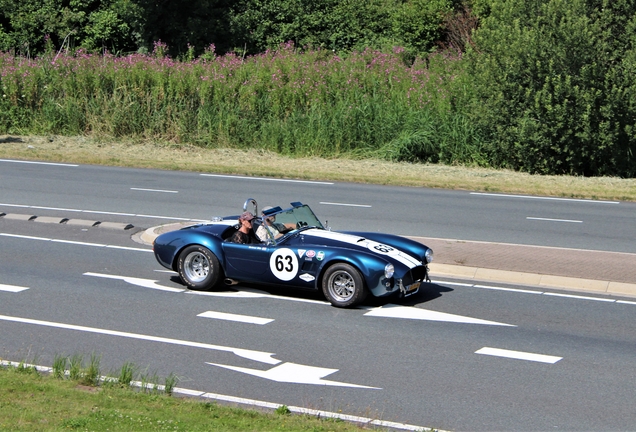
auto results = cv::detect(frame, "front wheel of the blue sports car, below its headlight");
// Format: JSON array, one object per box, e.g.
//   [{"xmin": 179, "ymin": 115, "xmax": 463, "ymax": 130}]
[{"xmin": 322, "ymin": 263, "xmax": 367, "ymax": 307}]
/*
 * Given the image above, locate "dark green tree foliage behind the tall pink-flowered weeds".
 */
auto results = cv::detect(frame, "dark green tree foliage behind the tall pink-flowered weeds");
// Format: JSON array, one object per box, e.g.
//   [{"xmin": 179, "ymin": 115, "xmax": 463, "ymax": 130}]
[{"xmin": 0, "ymin": 0, "xmax": 453, "ymax": 57}]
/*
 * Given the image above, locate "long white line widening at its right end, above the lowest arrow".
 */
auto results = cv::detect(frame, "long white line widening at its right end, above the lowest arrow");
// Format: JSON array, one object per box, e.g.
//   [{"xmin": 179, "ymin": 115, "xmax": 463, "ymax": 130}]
[{"xmin": 0, "ymin": 315, "xmax": 281, "ymax": 365}]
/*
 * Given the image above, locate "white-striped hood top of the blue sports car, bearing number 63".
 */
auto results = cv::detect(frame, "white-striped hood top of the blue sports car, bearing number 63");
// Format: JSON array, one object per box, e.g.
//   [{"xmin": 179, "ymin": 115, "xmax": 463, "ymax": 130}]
[{"xmin": 302, "ymin": 229, "xmax": 422, "ymax": 268}]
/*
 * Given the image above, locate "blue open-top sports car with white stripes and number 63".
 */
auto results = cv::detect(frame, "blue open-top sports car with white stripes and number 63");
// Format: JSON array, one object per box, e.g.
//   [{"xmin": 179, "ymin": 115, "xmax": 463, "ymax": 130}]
[{"xmin": 153, "ymin": 198, "xmax": 433, "ymax": 307}]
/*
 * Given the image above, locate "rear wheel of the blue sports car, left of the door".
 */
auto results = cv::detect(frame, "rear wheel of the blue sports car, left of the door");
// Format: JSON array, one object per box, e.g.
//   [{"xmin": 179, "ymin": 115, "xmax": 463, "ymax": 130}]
[{"xmin": 177, "ymin": 245, "xmax": 221, "ymax": 291}]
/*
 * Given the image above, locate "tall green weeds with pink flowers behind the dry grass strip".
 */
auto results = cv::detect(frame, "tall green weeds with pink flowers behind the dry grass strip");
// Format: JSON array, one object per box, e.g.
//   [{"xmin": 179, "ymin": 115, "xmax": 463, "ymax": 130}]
[{"xmin": 0, "ymin": 44, "xmax": 472, "ymax": 163}]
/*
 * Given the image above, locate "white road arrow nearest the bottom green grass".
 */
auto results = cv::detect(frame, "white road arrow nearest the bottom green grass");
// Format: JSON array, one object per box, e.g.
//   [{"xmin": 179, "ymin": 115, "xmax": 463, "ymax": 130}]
[{"xmin": 206, "ymin": 362, "xmax": 381, "ymax": 390}]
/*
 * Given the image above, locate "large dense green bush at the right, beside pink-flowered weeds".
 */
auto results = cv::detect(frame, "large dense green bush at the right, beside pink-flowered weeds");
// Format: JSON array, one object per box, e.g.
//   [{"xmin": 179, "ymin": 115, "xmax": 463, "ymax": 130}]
[{"xmin": 470, "ymin": 0, "xmax": 636, "ymax": 177}]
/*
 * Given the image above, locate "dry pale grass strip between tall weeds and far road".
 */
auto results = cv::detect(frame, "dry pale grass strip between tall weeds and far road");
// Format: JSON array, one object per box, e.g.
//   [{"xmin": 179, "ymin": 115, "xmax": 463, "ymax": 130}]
[{"xmin": 0, "ymin": 136, "xmax": 636, "ymax": 201}]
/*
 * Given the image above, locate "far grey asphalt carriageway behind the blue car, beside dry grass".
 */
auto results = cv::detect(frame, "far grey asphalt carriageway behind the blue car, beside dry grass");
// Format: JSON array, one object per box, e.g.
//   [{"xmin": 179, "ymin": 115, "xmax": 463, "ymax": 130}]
[{"xmin": 0, "ymin": 161, "xmax": 636, "ymax": 253}]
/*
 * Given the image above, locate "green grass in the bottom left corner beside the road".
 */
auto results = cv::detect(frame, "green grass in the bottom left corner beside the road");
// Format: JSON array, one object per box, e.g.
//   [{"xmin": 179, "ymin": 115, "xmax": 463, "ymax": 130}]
[{"xmin": 0, "ymin": 358, "xmax": 398, "ymax": 432}]
